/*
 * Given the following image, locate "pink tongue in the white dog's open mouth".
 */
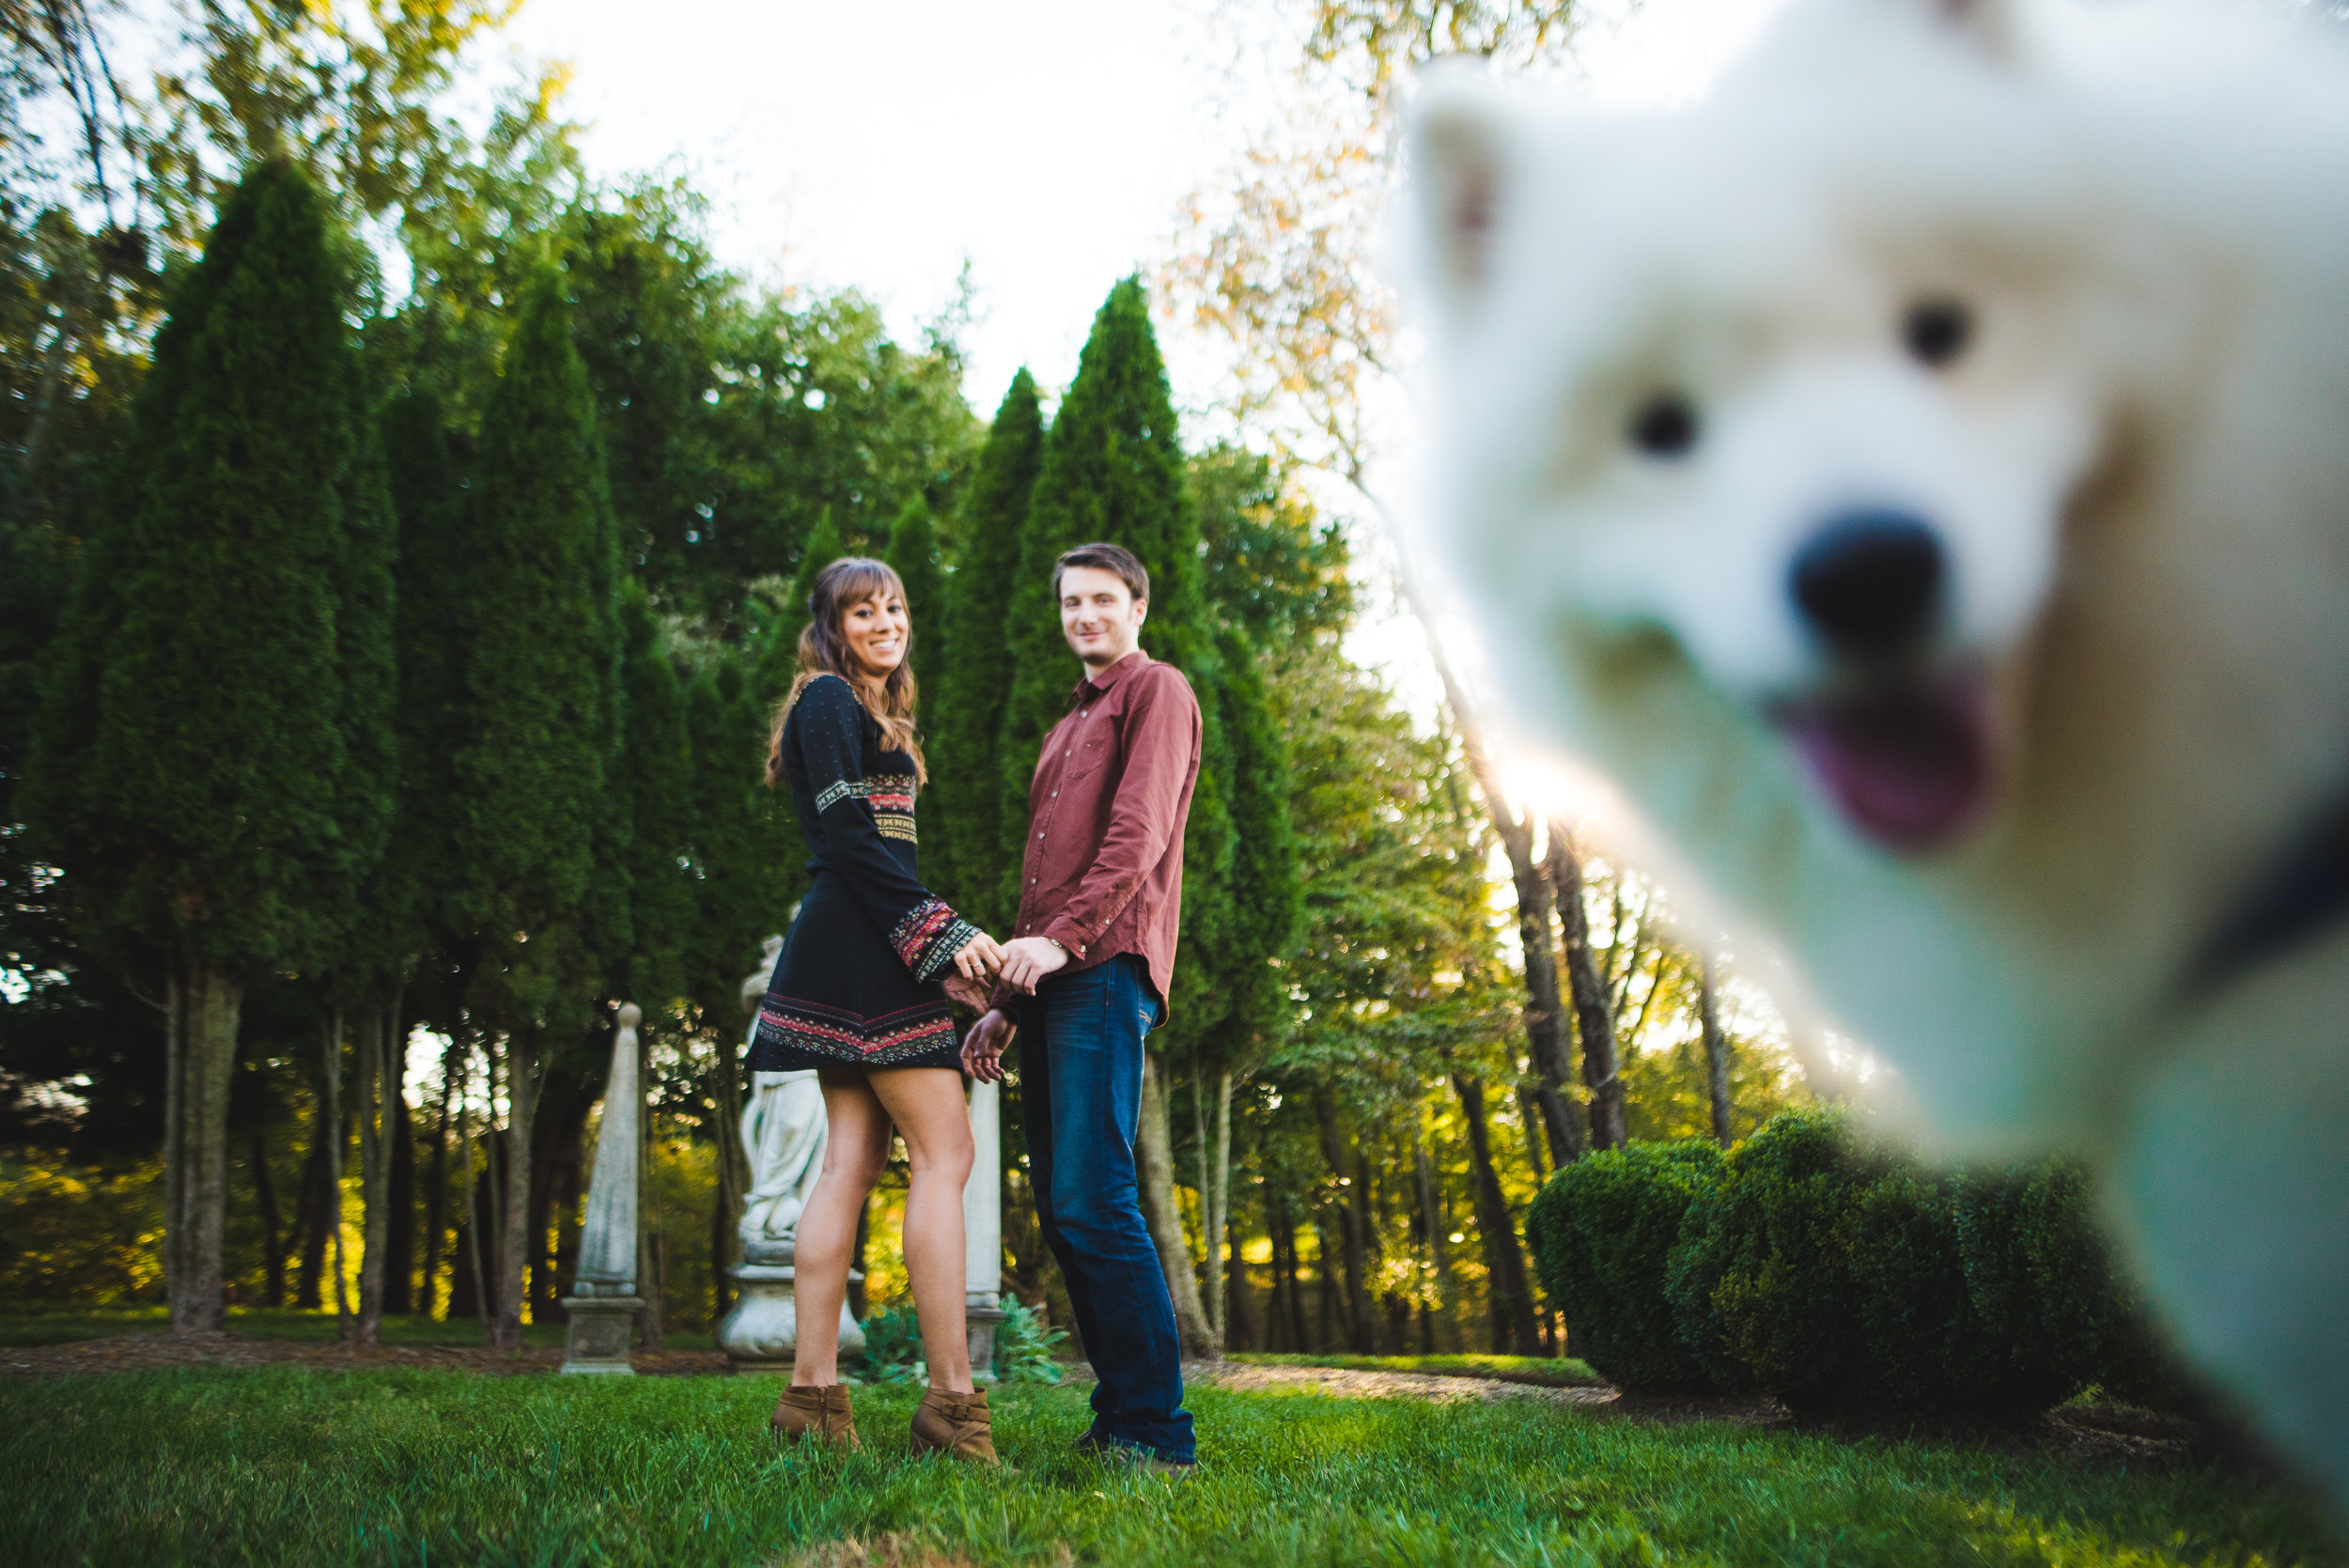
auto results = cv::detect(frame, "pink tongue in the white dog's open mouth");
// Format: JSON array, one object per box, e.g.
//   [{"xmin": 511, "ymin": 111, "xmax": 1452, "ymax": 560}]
[{"xmin": 1793, "ymin": 691, "xmax": 1990, "ymax": 849}]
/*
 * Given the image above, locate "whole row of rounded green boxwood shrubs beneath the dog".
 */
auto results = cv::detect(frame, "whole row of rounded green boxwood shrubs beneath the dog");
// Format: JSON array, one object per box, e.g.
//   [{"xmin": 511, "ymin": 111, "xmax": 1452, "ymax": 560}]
[{"xmin": 1527, "ymin": 1108, "xmax": 2175, "ymax": 1413}]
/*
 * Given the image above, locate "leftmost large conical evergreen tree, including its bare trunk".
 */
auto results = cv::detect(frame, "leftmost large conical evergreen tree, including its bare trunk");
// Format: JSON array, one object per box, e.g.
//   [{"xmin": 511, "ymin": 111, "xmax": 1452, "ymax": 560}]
[{"xmin": 36, "ymin": 162, "xmax": 390, "ymax": 1331}]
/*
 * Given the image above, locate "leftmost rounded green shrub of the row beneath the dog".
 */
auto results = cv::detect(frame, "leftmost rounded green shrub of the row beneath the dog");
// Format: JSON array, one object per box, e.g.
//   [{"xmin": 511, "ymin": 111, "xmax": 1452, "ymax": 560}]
[{"xmin": 1525, "ymin": 1141, "xmax": 1722, "ymax": 1392}]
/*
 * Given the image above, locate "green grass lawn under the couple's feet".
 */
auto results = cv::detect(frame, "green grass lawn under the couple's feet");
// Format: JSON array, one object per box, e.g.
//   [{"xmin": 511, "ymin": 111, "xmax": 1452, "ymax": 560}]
[{"xmin": 0, "ymin": 1366, "xmax": 2349, "ymax": 1568}]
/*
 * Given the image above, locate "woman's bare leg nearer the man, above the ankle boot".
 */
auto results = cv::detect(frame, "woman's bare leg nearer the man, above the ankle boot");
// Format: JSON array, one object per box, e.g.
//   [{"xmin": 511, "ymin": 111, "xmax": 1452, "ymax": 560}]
[{"xmin": 869, "ymin": 1068, "xmax": 971, "ymax": 1394}]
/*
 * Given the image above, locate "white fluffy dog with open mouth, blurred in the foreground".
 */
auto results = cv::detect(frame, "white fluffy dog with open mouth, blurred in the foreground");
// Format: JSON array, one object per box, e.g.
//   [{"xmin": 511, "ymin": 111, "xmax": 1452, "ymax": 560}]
[{"xmin": 1409, "ymin": 0, "xmax": 2349, "ymax": 1498}]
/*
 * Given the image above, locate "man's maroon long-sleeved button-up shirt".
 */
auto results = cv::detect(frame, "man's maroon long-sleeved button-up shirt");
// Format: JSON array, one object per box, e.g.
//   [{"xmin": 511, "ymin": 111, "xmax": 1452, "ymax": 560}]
[{"xmin": 996, "ymin": 648, "xmax": 1201, "ymax": 1007}]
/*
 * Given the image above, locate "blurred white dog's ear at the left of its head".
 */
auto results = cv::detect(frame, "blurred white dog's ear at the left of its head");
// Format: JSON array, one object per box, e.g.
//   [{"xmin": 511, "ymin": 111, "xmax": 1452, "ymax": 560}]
[{"xmin": 1405, "ymin": 61, "xmax": 1513, "ymax": 310}]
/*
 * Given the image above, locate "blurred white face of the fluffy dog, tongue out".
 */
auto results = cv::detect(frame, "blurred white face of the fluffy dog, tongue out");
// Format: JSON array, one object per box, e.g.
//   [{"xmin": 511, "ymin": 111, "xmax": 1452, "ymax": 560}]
[{"xmin": 1414, "ymin": 7, "xmax": 2147, "ymax": 854}]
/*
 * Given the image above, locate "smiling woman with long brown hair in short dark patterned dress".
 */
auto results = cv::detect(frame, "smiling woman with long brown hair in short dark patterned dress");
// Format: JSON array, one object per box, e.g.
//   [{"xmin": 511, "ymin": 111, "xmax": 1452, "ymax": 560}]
[{"xmin": 750, "ymin": 556, "xmax": 1003, "ymax": 1465}]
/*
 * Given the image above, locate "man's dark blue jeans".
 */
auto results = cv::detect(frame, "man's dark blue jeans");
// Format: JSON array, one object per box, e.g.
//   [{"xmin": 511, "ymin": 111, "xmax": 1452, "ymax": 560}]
[{"xmin": 1019, "ymin": 953, "xmax": 1198, "ymax": 1463}]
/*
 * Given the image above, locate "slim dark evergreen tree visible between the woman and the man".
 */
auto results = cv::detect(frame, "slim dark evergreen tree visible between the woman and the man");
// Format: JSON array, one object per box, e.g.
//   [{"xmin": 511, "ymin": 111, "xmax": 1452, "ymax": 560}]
[{"xmin": 921, "ymin": 368, "xmax": 1043, "ymax": 932}]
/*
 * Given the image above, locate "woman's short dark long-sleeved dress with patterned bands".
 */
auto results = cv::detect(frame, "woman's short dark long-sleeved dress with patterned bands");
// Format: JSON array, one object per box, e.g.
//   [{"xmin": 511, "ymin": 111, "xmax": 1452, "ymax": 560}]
[{"xmin": 750, "ymin": 676, "xmax": 977, "ymax": 1073}]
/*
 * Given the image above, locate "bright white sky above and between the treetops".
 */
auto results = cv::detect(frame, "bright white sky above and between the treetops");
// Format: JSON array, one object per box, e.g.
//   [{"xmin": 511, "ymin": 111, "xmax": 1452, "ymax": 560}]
[{"xmin": 507, "ymin": 0, "xmax": 1771, "ymax": 413}]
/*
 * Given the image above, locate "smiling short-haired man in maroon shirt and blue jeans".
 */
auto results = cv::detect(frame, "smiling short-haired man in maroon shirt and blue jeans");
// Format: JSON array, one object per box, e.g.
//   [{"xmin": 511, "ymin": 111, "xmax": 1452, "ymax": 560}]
[{"xmin": 963, "ymin": 545, "xmax": 1201, "ymax": 1469}]
